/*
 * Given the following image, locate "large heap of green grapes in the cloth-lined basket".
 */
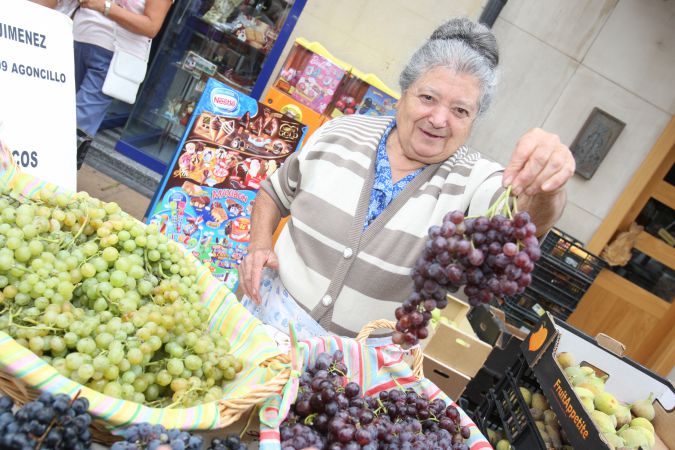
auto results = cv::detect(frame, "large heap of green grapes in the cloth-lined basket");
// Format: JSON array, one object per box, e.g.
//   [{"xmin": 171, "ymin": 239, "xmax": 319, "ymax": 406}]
[{"xmin": 0, "ymin": 188, "xmax": 242, "ymax": 407}]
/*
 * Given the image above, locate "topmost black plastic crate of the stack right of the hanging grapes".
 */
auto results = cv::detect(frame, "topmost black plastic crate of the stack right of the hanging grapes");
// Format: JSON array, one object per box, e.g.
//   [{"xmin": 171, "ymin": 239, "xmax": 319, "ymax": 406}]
[{"xmin": 541, "ymin": 228, "xmax": 607, "ymax": 282}]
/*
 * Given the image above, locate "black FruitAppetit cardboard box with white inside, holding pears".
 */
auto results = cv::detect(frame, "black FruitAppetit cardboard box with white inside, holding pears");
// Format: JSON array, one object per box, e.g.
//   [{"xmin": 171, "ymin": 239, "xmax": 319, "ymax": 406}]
[{"xmin": 521, "ymin": 313, "xmax": 675, "ymax": 450}]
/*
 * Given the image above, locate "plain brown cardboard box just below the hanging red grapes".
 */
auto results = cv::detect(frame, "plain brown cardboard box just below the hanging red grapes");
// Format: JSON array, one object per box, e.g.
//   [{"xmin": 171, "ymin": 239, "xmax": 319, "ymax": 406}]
[{"xmin": 423, "ymin": 323, "xmax": 492, "ymax": 399}]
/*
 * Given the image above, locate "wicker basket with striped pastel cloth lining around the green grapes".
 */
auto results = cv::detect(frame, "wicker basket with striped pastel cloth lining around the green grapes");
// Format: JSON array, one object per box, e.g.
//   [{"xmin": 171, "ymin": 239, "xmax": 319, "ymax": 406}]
[{"xmin": 0, "ymin": 142, "xmax": 290, "ymax": 445}]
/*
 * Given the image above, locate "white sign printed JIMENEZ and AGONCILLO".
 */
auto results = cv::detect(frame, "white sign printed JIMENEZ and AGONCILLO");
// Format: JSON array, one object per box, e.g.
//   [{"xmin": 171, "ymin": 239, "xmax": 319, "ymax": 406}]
[{"xmin": 0, "ymin": 0, "xmax": 77, "ymax": 191}]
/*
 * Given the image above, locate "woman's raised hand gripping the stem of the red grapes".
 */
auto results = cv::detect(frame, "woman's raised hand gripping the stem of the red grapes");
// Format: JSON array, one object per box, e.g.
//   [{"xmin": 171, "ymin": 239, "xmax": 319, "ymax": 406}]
[{"xmin": 503, "ymin": 128, "xmax": 576, "ymax": 197}]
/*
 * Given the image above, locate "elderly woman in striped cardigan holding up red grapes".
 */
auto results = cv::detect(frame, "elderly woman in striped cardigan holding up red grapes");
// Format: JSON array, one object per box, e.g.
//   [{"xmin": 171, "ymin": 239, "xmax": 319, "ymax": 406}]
[{"xmin": 240, "ymin": 19, "xmax": 574, "ymax": 342}]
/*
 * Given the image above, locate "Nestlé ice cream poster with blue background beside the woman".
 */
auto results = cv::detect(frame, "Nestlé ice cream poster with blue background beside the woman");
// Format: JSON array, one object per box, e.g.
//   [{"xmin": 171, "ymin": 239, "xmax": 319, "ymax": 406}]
[{"xmin": 148, "ymin": 79, "xmax": 305, "ymax": 291}]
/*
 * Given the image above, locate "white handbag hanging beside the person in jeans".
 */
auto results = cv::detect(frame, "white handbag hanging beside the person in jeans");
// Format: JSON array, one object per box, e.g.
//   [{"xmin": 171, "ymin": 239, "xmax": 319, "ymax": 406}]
[{"xmin": 101, "ymin": 26, "xmax": 150, "ymax": 104}]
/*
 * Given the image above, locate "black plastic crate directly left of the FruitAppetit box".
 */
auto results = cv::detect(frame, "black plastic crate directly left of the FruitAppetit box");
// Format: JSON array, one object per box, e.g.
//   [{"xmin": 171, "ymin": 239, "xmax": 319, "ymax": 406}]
[{"xmin": 473, "ymin": 357, "xmax": 546, "ymax": 450}]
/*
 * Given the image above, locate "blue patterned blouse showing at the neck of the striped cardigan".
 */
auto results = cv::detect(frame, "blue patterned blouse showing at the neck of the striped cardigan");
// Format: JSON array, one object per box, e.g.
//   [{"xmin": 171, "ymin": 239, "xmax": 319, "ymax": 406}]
[{"xmin": 363, "ymin": 120, "xmax": 424, "ymax": 230}]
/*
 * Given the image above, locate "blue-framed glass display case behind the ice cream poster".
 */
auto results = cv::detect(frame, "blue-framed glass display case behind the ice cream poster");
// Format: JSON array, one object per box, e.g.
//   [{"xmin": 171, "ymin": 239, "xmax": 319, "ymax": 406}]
[{"xmin": 116, "ymin": 0, "xmax": 306, "ymax": 173}]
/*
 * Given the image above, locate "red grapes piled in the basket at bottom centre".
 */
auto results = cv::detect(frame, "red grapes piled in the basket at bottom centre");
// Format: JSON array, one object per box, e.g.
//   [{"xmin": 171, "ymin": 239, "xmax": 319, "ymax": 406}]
[{"xmin": 280, "ymin": 350, "xmax": 471, "ymax": 450}]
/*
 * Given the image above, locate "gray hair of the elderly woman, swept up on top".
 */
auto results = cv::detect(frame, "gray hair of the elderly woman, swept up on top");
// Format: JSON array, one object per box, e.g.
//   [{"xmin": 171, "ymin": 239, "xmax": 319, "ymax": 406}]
[{"xmin": 399, "ymin": 18, "xmax": 499, "ymax": 114}]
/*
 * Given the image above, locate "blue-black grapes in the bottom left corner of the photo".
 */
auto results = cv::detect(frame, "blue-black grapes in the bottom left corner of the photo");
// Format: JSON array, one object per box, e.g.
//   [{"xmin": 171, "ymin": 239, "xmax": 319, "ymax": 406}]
[{"xmin": 0, "ymin": 392, "xmax": 91, "ymax": 450}]
